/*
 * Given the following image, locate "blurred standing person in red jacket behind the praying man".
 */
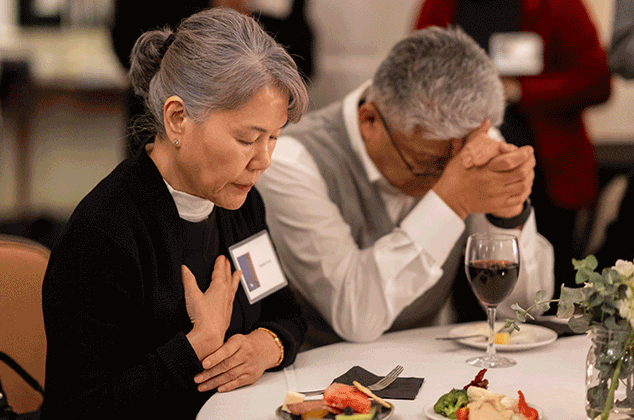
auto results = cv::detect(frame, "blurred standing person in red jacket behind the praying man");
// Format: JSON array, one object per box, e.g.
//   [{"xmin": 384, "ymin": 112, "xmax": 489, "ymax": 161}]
[{"xmin": 415, "ymin": 0, "xmax": 611, "ymax": 289}]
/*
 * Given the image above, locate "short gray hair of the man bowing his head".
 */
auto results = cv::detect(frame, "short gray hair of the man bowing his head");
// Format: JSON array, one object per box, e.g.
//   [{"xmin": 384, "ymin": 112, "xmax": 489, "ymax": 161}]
[{"xmin": 367, "ymin": 26, "xmax": 505, "ymax": 140}]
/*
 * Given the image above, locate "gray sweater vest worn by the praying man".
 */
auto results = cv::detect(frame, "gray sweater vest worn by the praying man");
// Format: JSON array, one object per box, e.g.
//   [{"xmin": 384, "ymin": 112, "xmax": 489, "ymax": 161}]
[{"xmin": 283, "ymin": 102, "xmax": 468, "ymax": 348}]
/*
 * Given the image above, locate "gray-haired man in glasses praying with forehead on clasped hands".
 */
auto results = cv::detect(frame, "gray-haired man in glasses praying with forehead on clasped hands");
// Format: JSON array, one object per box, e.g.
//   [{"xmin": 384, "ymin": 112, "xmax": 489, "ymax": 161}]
[{"xmin": 257, "ymin": 27, "xmax": 554, "ymax": 348}]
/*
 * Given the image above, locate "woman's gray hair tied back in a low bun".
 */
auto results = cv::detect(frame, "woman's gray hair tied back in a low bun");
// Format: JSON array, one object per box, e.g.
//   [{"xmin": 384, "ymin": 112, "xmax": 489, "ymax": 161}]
[{"xmin": 129, "ymin": 6, "xmax": 308, "ymax": 150}]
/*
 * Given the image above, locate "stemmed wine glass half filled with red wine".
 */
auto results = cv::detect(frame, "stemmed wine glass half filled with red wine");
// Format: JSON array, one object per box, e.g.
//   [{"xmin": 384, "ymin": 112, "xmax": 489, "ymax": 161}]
[{"xmin": 465, "ymin": 233, "xmax": 520, "ymax": 368}]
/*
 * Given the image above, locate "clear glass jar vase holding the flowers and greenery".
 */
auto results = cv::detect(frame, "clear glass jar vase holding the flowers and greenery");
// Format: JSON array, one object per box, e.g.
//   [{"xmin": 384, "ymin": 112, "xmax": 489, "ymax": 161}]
[{"xmin": 586, "ymin": 328, "xmax": 634, "ymax": 420}]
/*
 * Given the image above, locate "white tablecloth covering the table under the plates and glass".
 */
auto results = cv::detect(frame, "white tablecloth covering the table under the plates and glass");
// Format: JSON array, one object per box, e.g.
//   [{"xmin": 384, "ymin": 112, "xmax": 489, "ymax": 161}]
[{"xmin": 197, "ymin": 326, "xmax": 590, "ymax": 420}]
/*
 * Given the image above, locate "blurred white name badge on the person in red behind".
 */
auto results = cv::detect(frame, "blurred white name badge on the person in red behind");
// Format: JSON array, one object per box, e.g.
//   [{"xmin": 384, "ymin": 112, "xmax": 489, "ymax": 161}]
[{"xmin": 489, "ymin": 32, "xmax": 544, "ymax": 76}]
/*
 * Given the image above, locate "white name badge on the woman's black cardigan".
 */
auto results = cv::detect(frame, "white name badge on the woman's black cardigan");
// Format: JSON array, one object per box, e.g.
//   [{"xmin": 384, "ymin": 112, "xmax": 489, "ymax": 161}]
[{"xmin": 229, "ymin": 230, "xmax": 288, "ymax": 304}]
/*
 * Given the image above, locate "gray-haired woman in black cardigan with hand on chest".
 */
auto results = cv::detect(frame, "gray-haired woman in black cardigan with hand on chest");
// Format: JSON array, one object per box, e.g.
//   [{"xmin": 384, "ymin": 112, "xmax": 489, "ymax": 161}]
[{"xmin": 42, "ymin": 8, "xmax": 308, "ymax": 419}]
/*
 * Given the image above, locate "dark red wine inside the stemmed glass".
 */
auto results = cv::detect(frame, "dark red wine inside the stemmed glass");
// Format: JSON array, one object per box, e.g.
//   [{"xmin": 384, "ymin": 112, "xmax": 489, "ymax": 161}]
[{"xmin": 467, "ymin": 260, "xmax": 520, "ymax": 306}]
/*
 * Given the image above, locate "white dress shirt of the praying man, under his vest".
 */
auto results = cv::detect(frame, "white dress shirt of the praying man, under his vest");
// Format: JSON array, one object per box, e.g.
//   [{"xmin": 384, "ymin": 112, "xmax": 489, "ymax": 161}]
[{"xmin": 256, "ymin": 85, "xmax": 554, "ymax": 341}]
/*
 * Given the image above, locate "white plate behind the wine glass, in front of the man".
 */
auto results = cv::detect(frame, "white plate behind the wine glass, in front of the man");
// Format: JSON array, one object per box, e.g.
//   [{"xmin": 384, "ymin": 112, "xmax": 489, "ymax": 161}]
[{"xmin": 449, "ymin": 322, "xmax": 557, "ymax": 351}]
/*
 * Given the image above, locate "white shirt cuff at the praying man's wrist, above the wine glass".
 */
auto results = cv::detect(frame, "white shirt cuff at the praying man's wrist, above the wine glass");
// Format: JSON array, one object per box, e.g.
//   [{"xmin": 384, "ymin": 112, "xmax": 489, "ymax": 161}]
[{"xmin": 401, "ymin": 190, "xmax": 465, "ymax": 261}]
